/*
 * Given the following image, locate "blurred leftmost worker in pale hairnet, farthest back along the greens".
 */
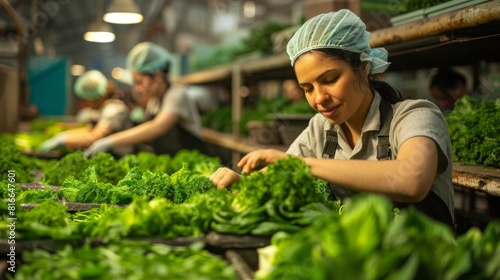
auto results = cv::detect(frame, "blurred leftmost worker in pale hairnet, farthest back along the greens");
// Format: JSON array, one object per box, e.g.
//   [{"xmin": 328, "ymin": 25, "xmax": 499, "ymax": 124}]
[{"xmin": 40, "ymin": 70, "xmax": 132, "ymax": 156}]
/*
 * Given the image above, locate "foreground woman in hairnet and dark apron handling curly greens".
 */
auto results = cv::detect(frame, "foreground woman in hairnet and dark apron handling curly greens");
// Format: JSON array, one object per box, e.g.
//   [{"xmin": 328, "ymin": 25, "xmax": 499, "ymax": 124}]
[{"xmin": 210, "ymin": 10, "xmax": 454, "ymax": 227}]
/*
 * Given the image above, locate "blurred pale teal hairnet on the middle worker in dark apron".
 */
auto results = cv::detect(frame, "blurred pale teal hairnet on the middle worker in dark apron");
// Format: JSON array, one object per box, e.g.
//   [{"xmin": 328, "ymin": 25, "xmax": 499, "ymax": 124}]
[{"xmin": 127, "ymin": 42, "xmax": 171, "ymax": 73}]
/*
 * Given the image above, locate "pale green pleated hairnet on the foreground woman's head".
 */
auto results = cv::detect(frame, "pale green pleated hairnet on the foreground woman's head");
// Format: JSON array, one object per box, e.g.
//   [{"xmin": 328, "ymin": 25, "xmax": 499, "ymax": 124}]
[{"xmin": 286, "ymin": 9, "xmax": 390, "ymax": 74}]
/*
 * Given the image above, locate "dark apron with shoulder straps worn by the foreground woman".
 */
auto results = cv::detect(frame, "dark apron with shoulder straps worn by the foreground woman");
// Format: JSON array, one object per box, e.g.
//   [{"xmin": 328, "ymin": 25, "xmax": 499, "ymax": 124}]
[{"xmin": 322, "ymin": 99, "xmax": 454, "ymax": 229}]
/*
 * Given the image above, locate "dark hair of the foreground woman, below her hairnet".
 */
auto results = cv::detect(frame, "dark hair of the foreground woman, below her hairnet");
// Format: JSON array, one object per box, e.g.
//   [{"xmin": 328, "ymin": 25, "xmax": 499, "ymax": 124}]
[{"xmin": 315, "ymin": 48, "xmax": 403, "ymax": 104}]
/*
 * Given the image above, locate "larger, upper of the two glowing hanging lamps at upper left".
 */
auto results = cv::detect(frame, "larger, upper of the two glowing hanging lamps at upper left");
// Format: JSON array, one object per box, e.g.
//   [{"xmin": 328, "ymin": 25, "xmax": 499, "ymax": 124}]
[{"xmin": 103, "ymin": 0, "xmax": 143, "ymax": 24}]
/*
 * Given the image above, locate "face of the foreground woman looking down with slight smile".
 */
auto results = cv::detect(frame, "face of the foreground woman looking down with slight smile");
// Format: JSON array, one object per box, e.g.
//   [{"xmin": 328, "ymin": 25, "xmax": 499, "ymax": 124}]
[{"xmin": 294, "ymin": 52, "xmax": 372, "ymax": 124}]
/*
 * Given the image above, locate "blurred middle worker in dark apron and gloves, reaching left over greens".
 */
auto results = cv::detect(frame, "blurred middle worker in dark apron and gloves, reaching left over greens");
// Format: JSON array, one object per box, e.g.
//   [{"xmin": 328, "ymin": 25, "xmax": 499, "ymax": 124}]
[{"xmin": 84, "ymin": 42, "xmax": 205, "ymax": 157}]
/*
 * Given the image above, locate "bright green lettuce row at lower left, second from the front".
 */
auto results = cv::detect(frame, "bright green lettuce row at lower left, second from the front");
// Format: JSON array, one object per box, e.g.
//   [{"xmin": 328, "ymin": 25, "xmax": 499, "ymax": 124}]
[{"xmin": 0, "ymin": 188, "xmax": 233, "ymax": 244}]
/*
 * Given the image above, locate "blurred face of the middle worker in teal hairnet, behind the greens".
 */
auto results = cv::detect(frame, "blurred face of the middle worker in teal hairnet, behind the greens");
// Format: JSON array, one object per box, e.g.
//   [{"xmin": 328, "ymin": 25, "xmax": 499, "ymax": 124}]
[{"xmin": 132, "ymin": 71, "xmax": 163, "ymax": 106}]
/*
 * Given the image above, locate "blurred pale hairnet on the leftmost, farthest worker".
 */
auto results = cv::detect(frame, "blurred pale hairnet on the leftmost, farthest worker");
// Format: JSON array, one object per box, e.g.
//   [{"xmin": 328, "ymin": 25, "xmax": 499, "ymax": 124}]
[{"xmin": 74, "ymin": 70, "xmax": 108, "ymax": 100}]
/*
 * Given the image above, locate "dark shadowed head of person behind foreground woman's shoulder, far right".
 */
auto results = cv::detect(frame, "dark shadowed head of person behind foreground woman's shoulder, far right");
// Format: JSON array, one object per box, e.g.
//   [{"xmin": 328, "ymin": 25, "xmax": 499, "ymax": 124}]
[{"xmin": 429, "ymin": 68, "xmax": 467, "ymax": 116}]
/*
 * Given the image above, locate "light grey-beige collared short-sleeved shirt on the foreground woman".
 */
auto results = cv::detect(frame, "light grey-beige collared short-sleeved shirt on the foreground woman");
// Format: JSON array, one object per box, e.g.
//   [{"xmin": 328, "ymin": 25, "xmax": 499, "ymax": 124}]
[{"xmin": 287, "ymin": 93, "xmax": 454, "ymax": 222}]
